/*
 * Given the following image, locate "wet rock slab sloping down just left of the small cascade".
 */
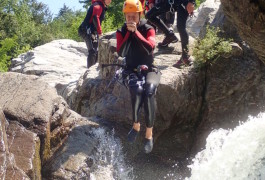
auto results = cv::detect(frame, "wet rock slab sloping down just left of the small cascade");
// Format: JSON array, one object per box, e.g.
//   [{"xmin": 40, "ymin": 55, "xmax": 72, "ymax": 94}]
[{"xmin": 44, "ymin": 121, "xmax": 97, "ymax": 179}]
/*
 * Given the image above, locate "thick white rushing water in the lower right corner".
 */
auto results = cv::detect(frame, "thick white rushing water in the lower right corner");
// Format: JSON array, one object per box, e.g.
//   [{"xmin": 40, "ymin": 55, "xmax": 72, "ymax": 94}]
[{"xmin": 186, "ymin": 113, "xmax": 265, "ymax": 180}]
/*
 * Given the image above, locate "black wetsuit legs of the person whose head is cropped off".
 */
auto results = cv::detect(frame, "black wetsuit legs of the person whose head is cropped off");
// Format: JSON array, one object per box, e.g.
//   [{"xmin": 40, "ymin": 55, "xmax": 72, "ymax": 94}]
[{"xmin": 145, "ymin": 0, "xmax": 195, "ymax": 58}]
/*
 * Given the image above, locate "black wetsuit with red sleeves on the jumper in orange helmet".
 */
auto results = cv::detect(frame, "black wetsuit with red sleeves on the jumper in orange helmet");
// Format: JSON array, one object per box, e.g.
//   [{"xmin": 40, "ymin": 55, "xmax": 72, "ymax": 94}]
[{"xmin": 117, "ymin": 20, "xmax": 161, "ymax": 128}]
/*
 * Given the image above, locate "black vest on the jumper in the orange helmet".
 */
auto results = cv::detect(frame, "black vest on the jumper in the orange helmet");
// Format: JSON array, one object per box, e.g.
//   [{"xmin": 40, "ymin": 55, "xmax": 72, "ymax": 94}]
[{"xmin": 118, "ymin": 19, "xmax": 154, "ymax": 69}]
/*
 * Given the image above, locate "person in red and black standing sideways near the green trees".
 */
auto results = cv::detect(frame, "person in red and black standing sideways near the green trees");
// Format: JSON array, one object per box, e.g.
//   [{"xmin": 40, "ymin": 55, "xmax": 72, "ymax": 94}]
[{"xmin": 78, "ymin": 0, "xmax": 111, "ymax": 68}]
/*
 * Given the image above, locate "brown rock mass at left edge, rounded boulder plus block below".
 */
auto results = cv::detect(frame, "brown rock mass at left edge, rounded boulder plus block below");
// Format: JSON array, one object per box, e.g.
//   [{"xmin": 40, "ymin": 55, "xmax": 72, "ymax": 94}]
[{"xmin": 0, "ymin": 72, "xmax": 95, "ymax": 179}]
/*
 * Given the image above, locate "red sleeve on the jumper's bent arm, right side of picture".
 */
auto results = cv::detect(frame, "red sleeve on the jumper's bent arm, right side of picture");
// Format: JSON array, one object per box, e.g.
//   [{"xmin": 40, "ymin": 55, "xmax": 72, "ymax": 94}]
[{"xmin": 135, "ymin": 28, "xmax": 155, "ymax": 54}]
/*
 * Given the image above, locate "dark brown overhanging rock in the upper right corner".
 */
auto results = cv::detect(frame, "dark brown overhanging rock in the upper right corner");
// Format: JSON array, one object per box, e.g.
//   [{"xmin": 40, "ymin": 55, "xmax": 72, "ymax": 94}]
[{"xmin": 221, "ymin": 0, "xmax": 265, "ymax": 63}]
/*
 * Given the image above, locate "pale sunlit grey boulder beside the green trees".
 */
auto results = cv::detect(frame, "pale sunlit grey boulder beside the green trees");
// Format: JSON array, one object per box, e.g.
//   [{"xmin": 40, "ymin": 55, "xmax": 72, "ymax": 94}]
[{"xmin": 11, "ymin": 39, "xmax": 87, "ymax": 93}]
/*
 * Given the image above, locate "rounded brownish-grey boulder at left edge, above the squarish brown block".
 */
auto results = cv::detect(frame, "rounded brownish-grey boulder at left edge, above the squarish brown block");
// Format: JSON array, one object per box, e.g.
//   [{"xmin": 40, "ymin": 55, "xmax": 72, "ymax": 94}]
[{"xmin": 0, "ymin": 72, "xmax": 81, "ymax": 165}]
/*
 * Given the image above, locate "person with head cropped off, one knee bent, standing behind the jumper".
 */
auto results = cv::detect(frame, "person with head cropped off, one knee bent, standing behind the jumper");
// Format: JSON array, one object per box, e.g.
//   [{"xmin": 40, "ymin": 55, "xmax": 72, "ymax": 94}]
[{"xmin": 145, "ymin": 0, "xmax": 195, "ymax": 68}]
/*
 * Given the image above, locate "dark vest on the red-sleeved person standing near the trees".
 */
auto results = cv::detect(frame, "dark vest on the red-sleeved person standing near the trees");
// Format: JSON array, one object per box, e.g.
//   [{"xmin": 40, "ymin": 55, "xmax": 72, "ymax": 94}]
[{"xmin": 80, "ymin": 0, "xmax": 107, "ymax": 32}]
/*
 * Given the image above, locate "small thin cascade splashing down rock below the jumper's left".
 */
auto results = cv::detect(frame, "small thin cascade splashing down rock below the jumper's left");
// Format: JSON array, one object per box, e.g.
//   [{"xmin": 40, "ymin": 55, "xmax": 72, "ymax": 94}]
[{"xmin": 90, "ymin": 128, "xmax": 133, "ymax": 180}]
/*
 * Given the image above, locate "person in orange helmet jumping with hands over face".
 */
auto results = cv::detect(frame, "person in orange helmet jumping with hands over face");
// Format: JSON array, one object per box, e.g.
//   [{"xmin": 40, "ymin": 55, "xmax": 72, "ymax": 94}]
[{"xmin": 116, "ymin": 0, "xmax": 161, "ymax": 153}]
